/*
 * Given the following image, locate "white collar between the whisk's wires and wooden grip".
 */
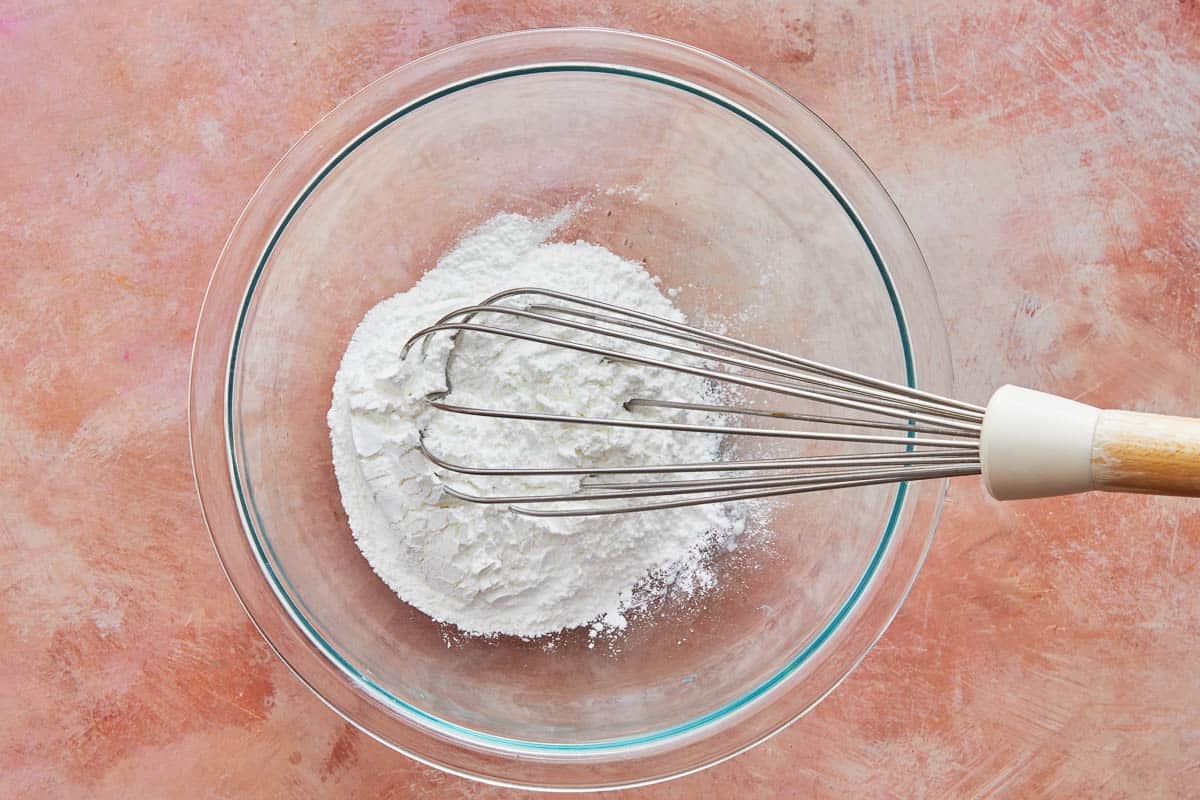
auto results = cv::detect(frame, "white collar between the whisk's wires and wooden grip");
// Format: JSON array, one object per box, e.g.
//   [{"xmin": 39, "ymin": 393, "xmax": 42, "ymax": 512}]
[{"xmin": 979, "ymin": 386, "xmax": 1100, "ymax": 500}]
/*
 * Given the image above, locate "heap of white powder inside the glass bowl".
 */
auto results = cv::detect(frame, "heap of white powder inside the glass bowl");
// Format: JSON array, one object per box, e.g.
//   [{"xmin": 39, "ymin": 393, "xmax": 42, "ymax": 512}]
[{"xmin": 329, "ymin": 212, "xmax": 744, "ymax": 637}]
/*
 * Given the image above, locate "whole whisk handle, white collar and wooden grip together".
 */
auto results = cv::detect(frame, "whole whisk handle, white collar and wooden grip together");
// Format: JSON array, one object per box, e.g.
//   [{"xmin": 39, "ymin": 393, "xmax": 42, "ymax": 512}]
[{"xmin": 979, "ymin": 386, "xmax": 1200, "ymax": 500}]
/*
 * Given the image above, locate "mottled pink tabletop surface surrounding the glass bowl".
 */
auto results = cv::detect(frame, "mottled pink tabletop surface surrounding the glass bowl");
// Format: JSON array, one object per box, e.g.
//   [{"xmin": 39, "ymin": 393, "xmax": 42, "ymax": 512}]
[{"xmin": 0, "ymin": 0, "xmax": 1200, "ymax": 799}]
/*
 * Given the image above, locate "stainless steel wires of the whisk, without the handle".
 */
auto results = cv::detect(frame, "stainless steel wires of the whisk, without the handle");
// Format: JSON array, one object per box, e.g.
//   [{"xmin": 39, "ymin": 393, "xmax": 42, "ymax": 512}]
[{"xmin": 402, "ymin": 288, "xmax": 985, "ymax": 517}]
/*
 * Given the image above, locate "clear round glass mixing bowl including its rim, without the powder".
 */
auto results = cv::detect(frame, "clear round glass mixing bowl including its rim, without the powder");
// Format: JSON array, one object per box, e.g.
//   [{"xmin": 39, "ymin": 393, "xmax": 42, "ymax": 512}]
[{"xmin": 190, "ymin": 29, "xmax": 952, "ymax": 789}]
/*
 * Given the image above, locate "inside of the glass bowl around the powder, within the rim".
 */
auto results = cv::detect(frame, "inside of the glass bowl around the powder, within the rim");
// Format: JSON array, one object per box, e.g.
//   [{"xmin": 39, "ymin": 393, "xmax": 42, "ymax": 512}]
[{"xmin": 229, "ymin": 68, "xmax": 910, "ymax": 748}]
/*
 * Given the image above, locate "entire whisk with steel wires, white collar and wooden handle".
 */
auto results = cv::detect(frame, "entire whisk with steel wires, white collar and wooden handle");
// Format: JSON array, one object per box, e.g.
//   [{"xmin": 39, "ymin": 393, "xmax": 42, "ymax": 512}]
[{"xmin": 403, "ymin": 288, "xmax": 1200, "ymax": 517}]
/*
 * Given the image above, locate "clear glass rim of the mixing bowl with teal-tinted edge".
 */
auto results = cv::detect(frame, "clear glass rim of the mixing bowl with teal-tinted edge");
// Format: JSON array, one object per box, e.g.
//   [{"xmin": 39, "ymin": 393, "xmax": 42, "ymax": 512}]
[{"xmin": 188, "ymin": 28, "xmax": 947, "ymax": 789}]
